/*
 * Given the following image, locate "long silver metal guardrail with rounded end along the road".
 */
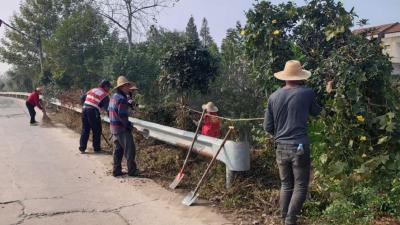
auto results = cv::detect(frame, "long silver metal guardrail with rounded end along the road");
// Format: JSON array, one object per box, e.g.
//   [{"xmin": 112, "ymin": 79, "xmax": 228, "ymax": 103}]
[{"xmin": 0, "ymin": 92, "xmax": 250, "ymax": 187}]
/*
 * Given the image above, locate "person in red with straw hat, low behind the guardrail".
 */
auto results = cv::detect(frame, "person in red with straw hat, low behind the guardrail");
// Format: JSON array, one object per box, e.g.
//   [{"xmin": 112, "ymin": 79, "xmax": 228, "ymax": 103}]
[{"xmin": 201, "ymin": 102, "xmax": 221, "ymax": 138}]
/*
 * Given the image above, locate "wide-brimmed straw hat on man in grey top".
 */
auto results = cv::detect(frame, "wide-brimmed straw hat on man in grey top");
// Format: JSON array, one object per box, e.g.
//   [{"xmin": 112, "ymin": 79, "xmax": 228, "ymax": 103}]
[{"xmin": 274, "ymin": 60, "xmax": 311, "ymax": 80}]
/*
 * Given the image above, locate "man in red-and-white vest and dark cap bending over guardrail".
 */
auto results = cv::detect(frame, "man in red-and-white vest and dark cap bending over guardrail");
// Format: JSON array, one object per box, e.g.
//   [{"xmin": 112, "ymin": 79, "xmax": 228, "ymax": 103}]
[{"xmin": 79, "ymin": 80, "xmax": 112, "ymax": 153}]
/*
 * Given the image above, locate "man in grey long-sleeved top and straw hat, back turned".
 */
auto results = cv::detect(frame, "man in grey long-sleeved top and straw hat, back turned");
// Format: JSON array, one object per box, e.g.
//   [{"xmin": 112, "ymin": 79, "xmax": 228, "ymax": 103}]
[{"xmin": 264, "ymin": 60, "xmax": 321, "ymax": 225}]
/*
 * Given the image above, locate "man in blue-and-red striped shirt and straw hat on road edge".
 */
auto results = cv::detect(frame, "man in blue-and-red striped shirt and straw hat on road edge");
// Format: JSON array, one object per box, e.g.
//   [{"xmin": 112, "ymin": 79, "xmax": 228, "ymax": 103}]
[{"xmin": 108, "ymin": 76, "xmax": 138, "ymax": 177}]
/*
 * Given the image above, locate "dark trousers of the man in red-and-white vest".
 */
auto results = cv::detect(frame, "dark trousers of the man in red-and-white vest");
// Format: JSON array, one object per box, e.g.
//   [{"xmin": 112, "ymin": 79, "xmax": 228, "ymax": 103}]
[{"xmin": 79, "ymin": 108, "xmax": 101, "ymax": 151}]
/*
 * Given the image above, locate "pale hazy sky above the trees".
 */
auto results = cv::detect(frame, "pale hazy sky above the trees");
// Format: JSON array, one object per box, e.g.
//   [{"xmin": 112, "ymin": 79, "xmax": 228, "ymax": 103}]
[{"xmin": 0, "ymin": 0, "xmax": 400, "ymax": 73}]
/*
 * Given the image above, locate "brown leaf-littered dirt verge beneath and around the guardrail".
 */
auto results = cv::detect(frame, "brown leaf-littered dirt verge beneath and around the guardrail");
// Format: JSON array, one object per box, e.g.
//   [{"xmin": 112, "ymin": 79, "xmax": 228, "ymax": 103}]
[{"xmin": 45, "ymin": 106, "xmax": 399, "ymax": 225}]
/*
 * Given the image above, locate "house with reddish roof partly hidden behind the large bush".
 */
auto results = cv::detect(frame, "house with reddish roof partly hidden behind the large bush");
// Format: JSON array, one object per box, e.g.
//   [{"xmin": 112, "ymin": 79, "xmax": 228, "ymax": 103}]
[{"xmin": 353, "ymin": 22, "xmax": 400, "ymax": 75}]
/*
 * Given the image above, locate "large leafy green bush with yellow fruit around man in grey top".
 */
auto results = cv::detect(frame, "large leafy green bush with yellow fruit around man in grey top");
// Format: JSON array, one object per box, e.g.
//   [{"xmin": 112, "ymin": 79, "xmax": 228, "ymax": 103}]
[{"xmin": 241, "ymin": 0, "xmax": 400, "ymax": 224}]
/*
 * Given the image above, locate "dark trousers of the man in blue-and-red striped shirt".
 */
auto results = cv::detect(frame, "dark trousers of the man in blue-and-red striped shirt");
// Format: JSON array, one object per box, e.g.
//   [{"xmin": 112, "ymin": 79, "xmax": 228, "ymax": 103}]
[{"xmin": 113, "ymin": 131, "xmax": 137, "ymax": 175}]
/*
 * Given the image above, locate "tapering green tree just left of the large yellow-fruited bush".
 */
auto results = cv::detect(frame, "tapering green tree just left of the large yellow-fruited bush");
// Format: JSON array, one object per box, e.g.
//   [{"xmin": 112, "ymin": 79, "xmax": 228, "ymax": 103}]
[{"xmin": 216, "ymin": 24, "xmax": 263, "ymax": 117}]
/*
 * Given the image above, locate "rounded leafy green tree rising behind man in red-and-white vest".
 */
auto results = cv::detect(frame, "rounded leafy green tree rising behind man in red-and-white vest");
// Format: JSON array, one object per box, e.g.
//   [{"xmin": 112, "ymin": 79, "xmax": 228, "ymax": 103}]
[{"xmin": 45, "ymin": 6, "xmax": 109, "ymax": 88}]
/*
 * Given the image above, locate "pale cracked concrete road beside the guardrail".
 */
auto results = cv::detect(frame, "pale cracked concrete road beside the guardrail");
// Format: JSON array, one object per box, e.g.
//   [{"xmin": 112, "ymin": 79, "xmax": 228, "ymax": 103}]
[{"xmin": 0, "ymin": 97, "xmax": 231, "ymax": 225}]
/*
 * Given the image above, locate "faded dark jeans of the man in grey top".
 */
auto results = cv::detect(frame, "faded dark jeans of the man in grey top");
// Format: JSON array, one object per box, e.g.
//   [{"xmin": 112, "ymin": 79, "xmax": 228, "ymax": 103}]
[{"xmin": 276, "ymin": 144, "xmax": 311, "ymax": 225}]
